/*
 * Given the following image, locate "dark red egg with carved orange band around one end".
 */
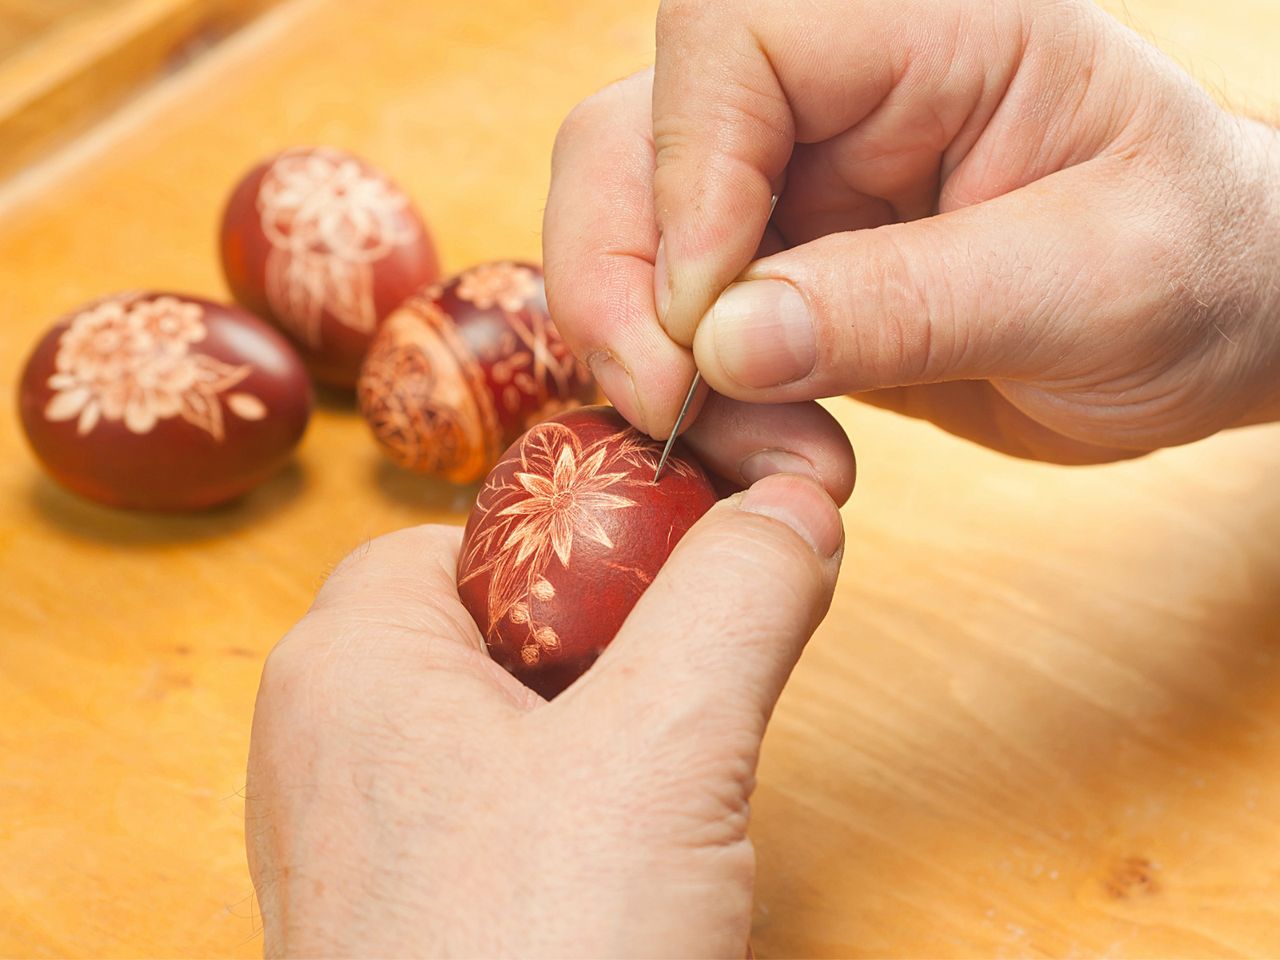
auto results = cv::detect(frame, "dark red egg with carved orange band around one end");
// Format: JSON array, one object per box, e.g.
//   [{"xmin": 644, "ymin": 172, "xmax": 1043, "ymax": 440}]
[{"xmin": 356, "ymin": 261, "xmax": 595, "ymax": 483}]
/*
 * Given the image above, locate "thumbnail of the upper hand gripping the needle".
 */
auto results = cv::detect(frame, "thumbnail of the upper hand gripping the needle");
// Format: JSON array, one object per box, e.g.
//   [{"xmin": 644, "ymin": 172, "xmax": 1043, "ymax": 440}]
[{"xmin": 704, "ymin": 280, "xmax": 818, "ymax": 388}]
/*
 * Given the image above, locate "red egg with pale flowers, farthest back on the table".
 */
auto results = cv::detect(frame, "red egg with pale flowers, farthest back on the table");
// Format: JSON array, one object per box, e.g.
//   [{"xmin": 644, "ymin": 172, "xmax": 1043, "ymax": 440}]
[{"xmin": 221, "ymin": 147, "xmax": 439, "ymax": 389}]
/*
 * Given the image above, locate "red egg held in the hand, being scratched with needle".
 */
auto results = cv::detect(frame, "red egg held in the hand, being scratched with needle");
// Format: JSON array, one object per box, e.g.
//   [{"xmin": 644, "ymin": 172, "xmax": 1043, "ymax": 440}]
[{"xmin": 458, "ymin": 407, "xmax": 716, "ymax": 698}]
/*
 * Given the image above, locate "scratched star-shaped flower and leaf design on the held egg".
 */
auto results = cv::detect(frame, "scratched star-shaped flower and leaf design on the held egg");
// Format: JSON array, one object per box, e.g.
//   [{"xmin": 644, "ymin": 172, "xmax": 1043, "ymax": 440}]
[{"xmin": 460, "ymin": 421, "xmax": 694, "ymax": 664}]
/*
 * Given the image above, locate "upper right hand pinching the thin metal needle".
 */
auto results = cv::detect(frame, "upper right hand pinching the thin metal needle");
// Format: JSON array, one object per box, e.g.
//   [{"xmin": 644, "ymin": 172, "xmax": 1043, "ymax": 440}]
[{"xmin": 544, "ymin": 0, "xmax": 1280, "ymax": 472}]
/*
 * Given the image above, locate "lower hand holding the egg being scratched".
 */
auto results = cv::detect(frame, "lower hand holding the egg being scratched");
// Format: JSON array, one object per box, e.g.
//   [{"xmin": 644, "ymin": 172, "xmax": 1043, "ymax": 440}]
[{"xmin": 246, "ymin": 476, "xmax": 842, "ymax": 957}]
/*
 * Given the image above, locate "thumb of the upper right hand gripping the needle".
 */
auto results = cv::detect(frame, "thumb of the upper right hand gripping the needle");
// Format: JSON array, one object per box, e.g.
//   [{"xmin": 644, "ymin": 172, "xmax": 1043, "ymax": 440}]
[{"xmin": 694, "ymin": 166, "xmax": 1126, "ymax": 403}]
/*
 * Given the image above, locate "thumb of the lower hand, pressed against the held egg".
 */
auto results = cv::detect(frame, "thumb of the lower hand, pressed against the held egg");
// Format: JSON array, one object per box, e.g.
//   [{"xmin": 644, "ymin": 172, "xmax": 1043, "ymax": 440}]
[{"xmin": 557, "ymin": 475, "xmax": 844, "ymax": 746}]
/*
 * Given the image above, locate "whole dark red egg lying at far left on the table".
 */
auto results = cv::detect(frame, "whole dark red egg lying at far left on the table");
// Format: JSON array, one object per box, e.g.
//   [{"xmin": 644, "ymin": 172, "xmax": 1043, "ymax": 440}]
[{"xmin": 18, "ymin": 293, "xmax": 311, "ymax": 511}]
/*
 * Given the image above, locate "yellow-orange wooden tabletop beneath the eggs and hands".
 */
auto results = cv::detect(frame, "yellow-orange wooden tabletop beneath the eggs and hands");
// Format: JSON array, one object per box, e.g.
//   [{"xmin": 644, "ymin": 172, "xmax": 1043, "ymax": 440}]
[{"xmin": 0, "ymin": 0, "xmax": 1280, "ymax": 957}]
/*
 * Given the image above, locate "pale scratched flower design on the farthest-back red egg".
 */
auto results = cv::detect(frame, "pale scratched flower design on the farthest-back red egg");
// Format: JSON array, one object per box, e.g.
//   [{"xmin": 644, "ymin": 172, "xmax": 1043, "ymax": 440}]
[{"xmin": 257, "ymin": 148, "xmax": 419, "ymax": 347}]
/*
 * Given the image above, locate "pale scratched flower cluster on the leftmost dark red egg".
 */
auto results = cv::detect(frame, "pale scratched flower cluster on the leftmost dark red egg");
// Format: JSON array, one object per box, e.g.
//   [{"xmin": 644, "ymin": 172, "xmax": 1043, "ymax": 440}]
[{"xmin": 45, "ymin": 296, "xmax": 266, "ymax": 440}]
